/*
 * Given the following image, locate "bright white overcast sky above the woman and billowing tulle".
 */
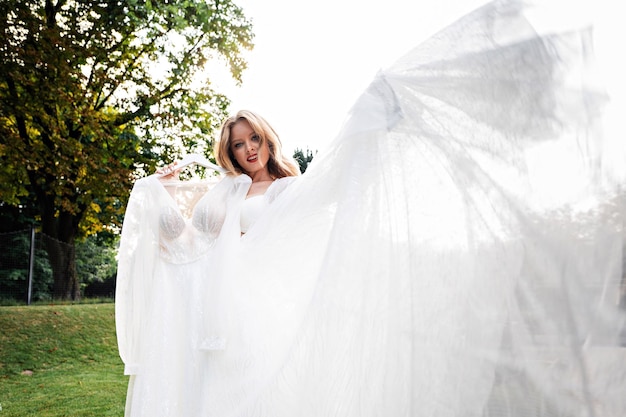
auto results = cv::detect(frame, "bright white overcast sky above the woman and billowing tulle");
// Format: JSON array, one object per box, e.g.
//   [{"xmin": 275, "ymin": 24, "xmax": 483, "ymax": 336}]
[{"xmin": 214, "ymin": 0, "xmax": 626, "ymax": 151}]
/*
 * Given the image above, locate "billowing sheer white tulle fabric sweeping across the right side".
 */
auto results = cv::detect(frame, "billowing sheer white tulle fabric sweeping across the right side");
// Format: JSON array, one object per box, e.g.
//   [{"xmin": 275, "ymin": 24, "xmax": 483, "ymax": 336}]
[{"xmin": 200, "ymin": 1, "xmax": 626, "ymax": 417}]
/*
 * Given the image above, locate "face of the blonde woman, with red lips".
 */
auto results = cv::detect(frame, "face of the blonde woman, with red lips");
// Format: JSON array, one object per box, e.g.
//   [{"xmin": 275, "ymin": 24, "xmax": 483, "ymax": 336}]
[{"xmin": 229, "ymin": 120, "xmax": 270, "ymax": 176}]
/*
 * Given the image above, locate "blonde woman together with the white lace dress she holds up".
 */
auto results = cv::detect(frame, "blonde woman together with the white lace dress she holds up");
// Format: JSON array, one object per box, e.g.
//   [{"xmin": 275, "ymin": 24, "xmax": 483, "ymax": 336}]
[{"xmin": 116, "ymin": 111, "xmax": 299, "ymax": 417}]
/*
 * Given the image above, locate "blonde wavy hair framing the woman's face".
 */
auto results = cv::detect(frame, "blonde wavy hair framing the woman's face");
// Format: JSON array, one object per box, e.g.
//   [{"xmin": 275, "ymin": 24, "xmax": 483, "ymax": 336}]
[{"xmin": 215, "ymin": 110, "xmax": 300, "ymax": 179}]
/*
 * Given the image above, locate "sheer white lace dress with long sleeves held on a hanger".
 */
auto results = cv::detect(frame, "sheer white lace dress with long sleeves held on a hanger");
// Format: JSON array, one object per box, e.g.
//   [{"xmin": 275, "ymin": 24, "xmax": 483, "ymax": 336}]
[{"xmin": 115, "ymin": 175, "xmax": 292, "ymax": 417}]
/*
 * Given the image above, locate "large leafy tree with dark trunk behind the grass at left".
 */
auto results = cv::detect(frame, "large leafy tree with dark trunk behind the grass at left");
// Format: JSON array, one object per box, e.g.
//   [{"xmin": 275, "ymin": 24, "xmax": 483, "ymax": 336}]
[{"xmin": 0, "ymin": 0, "xmax": 252, "ymax": 299}]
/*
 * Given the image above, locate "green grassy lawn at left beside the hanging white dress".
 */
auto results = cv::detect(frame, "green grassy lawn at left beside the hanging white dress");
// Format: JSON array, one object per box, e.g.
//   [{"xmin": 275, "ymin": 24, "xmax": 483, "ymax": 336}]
[{"xmin": 0, "ymin": 303, "xmax": 128, "ymax": 417}]
